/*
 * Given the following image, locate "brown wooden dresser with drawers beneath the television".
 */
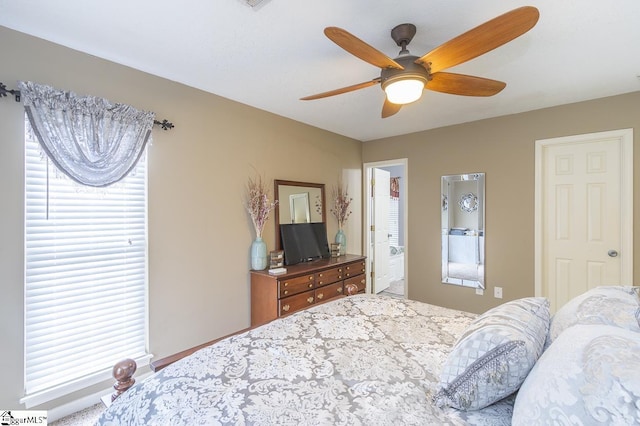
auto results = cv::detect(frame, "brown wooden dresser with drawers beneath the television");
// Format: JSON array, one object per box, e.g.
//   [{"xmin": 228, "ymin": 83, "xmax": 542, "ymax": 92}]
[{"xmin": 251, "ymin": 254, "xmax": 366, "ymax": 327}]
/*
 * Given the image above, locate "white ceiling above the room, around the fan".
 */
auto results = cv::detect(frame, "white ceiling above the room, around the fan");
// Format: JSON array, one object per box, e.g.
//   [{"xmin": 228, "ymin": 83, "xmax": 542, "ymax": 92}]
[{"xmin": 0, "ymin": 0, "xmax": 640, "ymax": 141}]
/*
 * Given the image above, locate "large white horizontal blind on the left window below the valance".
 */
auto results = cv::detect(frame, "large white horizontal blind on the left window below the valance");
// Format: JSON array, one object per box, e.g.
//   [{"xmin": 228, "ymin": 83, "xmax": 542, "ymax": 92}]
[{"xmin": 23, "ymin": 120, "xmax": 147, "ymax": 405}]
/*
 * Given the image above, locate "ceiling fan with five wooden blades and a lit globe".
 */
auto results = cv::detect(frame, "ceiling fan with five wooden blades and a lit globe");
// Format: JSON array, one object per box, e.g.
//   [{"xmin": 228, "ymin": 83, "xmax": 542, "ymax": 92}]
[{"xmin": 300, "ymin": 6, "xmax": 540, "ymax": 118}]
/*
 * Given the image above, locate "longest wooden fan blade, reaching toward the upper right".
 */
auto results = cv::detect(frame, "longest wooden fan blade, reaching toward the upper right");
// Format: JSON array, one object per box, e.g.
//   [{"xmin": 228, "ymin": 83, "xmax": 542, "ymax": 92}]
[{"xmin": 415, "ymin": 6, "xmax": 540, "ymax": 73}]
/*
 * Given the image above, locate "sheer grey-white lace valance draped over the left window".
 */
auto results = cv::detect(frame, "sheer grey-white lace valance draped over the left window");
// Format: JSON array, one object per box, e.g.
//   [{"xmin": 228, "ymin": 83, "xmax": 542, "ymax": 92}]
[{"xmin": 19, "ymin": 82, "xmax": 155, "ymax": 187}]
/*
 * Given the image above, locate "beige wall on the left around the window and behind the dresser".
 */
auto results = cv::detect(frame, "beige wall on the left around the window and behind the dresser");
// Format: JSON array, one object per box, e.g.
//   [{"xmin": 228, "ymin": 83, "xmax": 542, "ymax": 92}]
[{"xmin": 0, "ymin": 27, "xmax": 362, "ymax": 409}]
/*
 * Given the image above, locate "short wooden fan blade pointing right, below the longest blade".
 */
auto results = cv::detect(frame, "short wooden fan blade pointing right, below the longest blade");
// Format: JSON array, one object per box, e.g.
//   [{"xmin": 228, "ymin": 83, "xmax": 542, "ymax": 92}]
[{"xmin": 425, "ymin": 72, "xmax": 507, "ymax": 96}]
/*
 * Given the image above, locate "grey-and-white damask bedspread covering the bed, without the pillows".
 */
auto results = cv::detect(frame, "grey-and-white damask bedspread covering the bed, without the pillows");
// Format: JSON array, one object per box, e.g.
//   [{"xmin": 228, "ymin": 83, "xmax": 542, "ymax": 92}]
[{"xmin": 98, "ymin": 295, "xmax": 513, "ymax": 426}]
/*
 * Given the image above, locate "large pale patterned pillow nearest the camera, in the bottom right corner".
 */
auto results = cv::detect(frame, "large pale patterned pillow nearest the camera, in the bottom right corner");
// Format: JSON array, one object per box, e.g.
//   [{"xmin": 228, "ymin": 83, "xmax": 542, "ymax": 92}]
[{"xmin": 512, "ymin": 325, "xmax": 640, "ymax": 426}]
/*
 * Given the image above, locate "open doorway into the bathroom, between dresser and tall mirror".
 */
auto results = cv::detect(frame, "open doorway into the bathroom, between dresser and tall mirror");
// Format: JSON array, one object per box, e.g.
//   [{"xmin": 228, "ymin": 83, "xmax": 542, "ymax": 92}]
[{"xmin": 363, "ymin": 158, "xmax": 409, "ymax": 298}]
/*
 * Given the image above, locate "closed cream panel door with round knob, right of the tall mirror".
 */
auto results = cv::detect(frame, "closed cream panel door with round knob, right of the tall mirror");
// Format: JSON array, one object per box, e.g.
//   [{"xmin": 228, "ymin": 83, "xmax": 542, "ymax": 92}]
[{"xmin": 537, "ymin": 128, "xmax": 633, "ymax": 312}]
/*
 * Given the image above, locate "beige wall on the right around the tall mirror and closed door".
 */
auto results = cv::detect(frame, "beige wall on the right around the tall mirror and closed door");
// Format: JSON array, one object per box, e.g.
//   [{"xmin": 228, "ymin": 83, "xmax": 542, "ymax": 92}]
[{"xmin": 363, "ymin": 92, "xmax": 640, "ymax": 312}]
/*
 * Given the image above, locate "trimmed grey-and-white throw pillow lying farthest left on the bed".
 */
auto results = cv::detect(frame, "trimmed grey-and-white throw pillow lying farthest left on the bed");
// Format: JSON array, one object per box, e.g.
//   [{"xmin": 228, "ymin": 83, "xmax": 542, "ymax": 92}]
[{"xmin": 434, "ymin": 297, "xmax": 549, "ymax": 410}]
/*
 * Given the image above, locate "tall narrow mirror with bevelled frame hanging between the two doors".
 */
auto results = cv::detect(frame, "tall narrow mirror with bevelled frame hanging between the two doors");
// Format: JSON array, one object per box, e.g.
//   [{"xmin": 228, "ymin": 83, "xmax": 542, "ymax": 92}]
[{"xmin": 441, "ymin": 173, "xmax": 485, "ymax": 288}]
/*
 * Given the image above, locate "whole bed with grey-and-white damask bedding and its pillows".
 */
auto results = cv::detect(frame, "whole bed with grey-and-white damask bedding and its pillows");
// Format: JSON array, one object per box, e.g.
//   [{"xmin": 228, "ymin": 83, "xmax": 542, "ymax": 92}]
[{"xmin": 97, "ymin": 287, "xmax": 640, "ymax": 426}]
